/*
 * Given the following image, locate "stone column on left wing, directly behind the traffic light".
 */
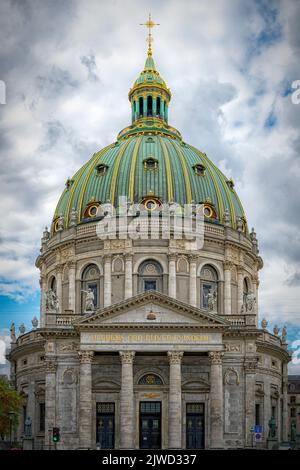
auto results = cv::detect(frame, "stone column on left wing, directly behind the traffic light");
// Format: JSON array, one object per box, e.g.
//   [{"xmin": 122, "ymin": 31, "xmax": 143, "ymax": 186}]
[{"xmin": 45, "ymin": 357, "xmax": 57, "ymax": 449}]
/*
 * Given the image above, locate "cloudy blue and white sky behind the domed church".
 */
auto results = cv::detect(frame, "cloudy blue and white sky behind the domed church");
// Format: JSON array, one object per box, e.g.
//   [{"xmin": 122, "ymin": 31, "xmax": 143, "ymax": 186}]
[{"xmin": 0, "ymin": 0, "xmax": 300, "ymax": 373}]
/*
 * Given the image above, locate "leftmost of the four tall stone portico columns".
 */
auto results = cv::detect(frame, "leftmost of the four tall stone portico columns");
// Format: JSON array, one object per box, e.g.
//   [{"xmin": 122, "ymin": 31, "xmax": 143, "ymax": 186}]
[{"xmin": 78, "ymin": 351, "xmax": 94, "ymax": 449}]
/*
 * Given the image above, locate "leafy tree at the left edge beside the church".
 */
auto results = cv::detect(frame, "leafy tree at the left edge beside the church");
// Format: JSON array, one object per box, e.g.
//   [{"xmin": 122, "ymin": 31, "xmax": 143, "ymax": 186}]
[{"xmin": 0, "ymin": 379, "xmax": 22, "ymax": 437}]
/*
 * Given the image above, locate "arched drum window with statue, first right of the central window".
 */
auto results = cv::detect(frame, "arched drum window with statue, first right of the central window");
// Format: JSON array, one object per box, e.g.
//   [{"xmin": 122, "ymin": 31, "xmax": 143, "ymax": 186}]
[{"xmin": 200, "ymin": 265, "xmax": 218, "ymax": 311}]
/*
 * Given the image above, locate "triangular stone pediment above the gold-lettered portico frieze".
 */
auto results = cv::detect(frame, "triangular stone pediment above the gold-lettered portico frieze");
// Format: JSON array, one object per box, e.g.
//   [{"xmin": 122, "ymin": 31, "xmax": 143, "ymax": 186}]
[{"xmin": 74, "ymin": 291, "xmax": 229, "ymax": 329}]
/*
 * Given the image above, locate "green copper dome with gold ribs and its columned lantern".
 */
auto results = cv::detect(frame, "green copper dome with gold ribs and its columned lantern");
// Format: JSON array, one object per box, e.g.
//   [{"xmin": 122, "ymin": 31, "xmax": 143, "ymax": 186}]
[{"xmin": 52, "ymin": 47, "xmax": 247, "ymax": 233}]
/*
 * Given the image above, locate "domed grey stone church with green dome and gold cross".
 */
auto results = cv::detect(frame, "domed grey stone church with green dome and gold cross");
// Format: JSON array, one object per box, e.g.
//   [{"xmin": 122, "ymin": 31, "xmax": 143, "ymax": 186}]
[{"xmin": 9, "ymin": 19, "xmax": 290, "ymax": 449}]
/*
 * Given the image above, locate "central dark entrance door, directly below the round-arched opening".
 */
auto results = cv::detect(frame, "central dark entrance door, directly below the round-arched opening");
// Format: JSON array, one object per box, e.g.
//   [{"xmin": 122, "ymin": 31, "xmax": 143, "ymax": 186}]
[{"xmin": 140, "ymin": 401, "xmax": 161, "ymax": 449}]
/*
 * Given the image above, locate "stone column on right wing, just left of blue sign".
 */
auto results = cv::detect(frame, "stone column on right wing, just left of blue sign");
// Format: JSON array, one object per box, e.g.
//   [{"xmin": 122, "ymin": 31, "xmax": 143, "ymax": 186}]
[{"xmin": 244, "ymin": 357, "xmax": 257, "ymax": 447}]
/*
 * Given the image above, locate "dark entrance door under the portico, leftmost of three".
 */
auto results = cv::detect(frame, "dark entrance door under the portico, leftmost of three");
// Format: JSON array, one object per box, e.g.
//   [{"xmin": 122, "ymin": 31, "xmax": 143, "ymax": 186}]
[{"xmin": 96, "ymin": 403, "xmax": 115, "ymax": 449}]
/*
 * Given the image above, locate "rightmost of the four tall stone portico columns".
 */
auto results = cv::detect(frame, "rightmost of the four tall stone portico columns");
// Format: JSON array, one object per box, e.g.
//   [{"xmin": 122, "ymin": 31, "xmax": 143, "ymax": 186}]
[{"xmin": 209, "ymin": 351, "xmax": 224, "ymax": 449}]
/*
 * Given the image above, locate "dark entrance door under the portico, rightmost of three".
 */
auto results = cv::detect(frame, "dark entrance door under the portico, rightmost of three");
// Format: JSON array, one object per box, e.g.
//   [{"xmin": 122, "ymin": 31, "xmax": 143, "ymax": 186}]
[{"xmin": 186, "ymin": 403, "xmax": 204, "ymax": 449}]
